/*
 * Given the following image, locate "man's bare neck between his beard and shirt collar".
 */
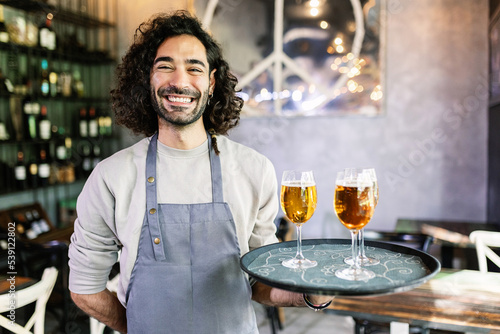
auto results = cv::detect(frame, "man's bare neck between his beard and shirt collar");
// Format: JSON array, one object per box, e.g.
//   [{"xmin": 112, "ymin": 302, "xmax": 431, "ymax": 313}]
[{"xmin": 158, "ymin": 122, "xmax": 207, "ymax": 150}]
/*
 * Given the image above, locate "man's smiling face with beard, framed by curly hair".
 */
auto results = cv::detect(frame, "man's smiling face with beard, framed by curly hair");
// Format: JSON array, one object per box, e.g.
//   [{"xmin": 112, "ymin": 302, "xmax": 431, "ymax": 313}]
[{"xmin": 151, "ymin": 35, "xmax": 215, "ymax": 126}]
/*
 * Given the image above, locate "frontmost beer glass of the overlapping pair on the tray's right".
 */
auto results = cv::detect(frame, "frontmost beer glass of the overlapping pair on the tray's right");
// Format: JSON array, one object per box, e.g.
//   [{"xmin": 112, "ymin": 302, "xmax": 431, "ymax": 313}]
[{"xmin": 333, "ymin": 168, "xmax": 375, "ymax": 281}]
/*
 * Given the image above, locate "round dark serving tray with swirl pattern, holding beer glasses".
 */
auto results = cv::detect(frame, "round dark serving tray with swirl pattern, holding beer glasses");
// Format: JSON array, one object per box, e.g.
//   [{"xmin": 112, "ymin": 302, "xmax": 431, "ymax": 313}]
[{"xmin": 240, "ymin": 239, "xmax": 441, "ymax": 296}]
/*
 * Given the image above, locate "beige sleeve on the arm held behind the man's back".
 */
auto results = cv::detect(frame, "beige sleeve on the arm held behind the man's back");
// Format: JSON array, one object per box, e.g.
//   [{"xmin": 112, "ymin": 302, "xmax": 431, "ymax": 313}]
[{"xmin": 69, "ymin": 165, "xmax": 120, "ymax": 294}]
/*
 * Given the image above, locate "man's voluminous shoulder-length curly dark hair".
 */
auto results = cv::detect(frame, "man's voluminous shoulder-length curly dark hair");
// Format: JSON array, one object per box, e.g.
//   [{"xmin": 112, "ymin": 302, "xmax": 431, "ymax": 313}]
[{"xmin": 111, "ymin": 10, "xmax": 243, "ymax": 136}]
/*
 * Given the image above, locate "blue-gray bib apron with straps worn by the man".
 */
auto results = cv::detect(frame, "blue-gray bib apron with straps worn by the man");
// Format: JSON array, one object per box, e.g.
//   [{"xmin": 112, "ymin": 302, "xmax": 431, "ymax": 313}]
[{"xmin": 126, "ymin": 134, "xmax": 258, "ymax": 334}]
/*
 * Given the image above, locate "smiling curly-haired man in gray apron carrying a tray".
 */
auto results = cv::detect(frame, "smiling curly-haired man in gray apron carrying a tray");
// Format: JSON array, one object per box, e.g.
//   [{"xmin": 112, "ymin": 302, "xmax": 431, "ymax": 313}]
[{"xmin": 69, "ymin": 12, "xmax": 331, "ymax": 334}]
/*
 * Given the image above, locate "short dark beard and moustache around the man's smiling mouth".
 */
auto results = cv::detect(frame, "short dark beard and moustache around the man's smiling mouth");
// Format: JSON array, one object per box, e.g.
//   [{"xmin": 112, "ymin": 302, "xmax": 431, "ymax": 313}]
[{"xmin": 151, "ymin": 86, "xmax": 209, "ymax": 127}]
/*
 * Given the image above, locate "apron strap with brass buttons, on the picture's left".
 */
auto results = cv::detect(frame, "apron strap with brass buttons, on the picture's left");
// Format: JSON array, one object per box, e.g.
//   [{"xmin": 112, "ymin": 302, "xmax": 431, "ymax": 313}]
[{"xmin": 146, "ymin": 133, "xmax": 165, "ymax": 261}]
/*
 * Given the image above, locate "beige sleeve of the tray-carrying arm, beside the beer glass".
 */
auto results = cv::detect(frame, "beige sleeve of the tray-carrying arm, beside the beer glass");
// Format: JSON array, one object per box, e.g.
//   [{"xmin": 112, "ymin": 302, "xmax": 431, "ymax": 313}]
[{"xmin": 249, "ymin": 158, "xmax": 279, "ymax": 250}]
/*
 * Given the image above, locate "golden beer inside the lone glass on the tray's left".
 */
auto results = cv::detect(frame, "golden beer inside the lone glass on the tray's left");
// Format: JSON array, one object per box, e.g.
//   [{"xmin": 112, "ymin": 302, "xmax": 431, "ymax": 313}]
[{"xmin": 281, "ymin": 181, "xmax": 317, "ymax": 225}]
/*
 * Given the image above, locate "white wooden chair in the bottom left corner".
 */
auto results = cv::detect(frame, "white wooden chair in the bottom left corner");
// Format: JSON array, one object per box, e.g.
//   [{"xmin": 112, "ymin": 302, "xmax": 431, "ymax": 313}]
[{"xmin": 0, "ymin": 267, "xmax": 58, "ymax": 334}]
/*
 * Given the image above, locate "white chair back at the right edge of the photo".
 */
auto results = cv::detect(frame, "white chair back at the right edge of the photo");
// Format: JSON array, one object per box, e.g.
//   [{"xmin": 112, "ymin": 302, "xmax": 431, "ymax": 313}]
[{"xmin": 469, "ymin": 231, "xmax": 500, "ymax": 273}]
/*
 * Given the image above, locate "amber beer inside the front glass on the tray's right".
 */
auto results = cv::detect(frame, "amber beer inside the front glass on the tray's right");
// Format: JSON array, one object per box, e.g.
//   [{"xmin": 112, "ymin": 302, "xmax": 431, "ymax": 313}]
[{"xmin": 333, "ymin": 185, "xmax": 375, "ymax": 230}]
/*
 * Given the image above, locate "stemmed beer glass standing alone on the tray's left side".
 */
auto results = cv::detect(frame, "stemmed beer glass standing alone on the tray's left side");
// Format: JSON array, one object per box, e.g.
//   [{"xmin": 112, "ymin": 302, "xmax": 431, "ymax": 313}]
[{"xmin": 280, "ymin": 170, "xmax": 318, "ymax": 269}]
